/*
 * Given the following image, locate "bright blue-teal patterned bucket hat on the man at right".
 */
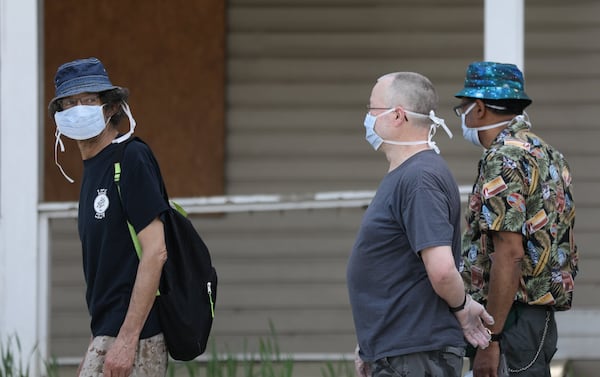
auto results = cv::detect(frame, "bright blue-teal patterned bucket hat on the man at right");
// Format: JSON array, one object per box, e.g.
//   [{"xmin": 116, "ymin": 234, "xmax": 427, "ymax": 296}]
[{"xmin": 454, "ymin": 62, "xmax": 531, "ymax": 104}]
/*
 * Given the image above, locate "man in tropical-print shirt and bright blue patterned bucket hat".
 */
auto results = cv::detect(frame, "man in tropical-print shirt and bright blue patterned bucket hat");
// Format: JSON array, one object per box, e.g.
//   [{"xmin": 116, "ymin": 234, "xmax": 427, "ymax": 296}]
[{"xmin": 454, "ymin": 62, "xmax": 578, "ymax": 377}]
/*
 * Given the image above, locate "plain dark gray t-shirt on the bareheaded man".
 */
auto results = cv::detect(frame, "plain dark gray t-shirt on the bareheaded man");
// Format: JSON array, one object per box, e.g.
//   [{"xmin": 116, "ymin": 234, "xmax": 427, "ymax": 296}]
[{"xmin": 347, "ymin": 150, "xmax": 465, "ymax": 361}]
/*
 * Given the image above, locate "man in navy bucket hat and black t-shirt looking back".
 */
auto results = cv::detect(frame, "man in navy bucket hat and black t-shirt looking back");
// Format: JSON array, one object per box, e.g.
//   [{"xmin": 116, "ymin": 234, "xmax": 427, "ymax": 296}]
[{"xmin": 48, "ymin": 58, "xmax": 168, "ymax": 377}]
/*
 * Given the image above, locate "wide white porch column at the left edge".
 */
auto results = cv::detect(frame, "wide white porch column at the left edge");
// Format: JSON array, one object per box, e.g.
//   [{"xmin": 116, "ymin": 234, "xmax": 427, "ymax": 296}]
[{"xmin": 0, "ymin": 0, "xmax": 47, "ymax": 376}]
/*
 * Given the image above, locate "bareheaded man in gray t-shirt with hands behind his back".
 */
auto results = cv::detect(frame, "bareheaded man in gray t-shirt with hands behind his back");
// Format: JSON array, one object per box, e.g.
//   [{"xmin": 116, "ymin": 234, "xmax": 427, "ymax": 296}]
[{"xmin": 347, "ymin": 72, "xmax": 493, "ymax": 377}]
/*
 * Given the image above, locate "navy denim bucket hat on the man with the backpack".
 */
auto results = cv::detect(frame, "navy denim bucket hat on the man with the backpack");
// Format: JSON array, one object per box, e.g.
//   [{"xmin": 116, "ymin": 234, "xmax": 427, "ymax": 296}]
[{"xmin": 48, "ymin": 57, "xmax": 128, "ymax": 114}]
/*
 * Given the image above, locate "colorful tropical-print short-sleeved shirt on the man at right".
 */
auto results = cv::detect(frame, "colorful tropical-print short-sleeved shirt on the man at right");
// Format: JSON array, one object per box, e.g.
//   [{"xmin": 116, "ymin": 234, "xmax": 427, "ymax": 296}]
[{"xmin": 461, "ymin": 119, "xmax": 578, "ymax": 310}]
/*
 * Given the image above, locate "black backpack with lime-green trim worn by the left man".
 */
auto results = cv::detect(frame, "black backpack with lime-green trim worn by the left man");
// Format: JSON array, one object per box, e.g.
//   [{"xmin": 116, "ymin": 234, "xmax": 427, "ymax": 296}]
[{"xmin": 114, "ymin": 137, "xmax": 217, "ymax": 361}]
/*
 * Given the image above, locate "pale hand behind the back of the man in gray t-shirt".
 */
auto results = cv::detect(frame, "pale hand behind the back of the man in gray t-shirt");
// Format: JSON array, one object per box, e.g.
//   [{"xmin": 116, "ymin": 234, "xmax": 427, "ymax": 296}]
[{"xmin": 454, "ymin": 295, "xmax": 494, "ymax": 349}]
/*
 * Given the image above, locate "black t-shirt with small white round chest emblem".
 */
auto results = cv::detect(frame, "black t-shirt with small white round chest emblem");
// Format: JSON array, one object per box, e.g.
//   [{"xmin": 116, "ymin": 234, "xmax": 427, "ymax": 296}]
[{"xmin": 78, "ymin": 141, "xmax": 168, "ymax": 339}]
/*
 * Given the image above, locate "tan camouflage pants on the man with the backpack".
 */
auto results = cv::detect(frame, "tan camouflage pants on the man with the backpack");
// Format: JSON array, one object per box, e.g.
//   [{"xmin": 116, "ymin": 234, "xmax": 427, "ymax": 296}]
[{"xmin": 79, "ymin": 334, "xmax": 168, "ymax": 377}]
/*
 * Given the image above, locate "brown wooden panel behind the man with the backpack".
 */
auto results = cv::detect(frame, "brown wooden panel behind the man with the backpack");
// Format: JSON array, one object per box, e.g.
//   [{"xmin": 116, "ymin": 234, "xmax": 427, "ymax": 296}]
[{"xmin": 44, "ymin": 0, "xmax": 225, "ymax": 201}]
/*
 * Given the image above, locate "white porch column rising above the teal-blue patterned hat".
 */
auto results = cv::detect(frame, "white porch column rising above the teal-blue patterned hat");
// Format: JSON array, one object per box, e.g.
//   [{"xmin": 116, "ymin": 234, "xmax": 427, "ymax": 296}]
[{"xmin": 483, "ymin": 0, "xmax": 525, "ymax": 70}]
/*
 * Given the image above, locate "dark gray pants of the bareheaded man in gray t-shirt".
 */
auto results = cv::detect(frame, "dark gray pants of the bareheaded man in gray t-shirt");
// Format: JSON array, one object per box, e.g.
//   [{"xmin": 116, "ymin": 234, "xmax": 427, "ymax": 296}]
[{"xmin": 370, "ymin": 347, "xmax": 465, "ymax": 377}]
